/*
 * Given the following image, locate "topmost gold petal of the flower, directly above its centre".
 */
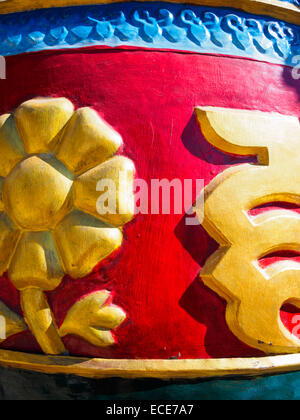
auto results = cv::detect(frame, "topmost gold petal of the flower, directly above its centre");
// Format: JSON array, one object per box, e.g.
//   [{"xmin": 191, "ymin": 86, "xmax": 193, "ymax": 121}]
[{"xmin": 14, "ymin": 98, "xmax": 74, "ymax": 154}]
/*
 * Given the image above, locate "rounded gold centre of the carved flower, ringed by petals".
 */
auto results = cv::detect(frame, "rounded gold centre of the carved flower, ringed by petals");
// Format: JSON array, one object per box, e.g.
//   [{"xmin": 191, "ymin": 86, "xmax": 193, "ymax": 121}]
[{"xmin": 3, "ymin": 156, "xmax": 73, "ymax": 231}]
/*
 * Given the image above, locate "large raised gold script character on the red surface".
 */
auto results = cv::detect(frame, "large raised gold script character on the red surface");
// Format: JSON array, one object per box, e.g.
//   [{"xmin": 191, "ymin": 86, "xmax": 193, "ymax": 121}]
[{"xmin": 196, "ymin": 107, "xmax": 300, "ymax": 354}]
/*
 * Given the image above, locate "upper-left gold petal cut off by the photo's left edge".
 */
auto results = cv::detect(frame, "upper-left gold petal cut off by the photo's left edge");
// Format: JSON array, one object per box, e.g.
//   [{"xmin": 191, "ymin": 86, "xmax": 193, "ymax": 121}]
[{"xmin": 0, "ymin": 114, "xmax": 25, "ymax": 177}]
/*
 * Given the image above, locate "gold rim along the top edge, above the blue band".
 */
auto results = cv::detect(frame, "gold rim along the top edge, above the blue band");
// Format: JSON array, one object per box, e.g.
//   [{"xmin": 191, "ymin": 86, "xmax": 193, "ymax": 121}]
[{"xmin": 0, "ymin": 0, "xmax": 300, "ymax": 25}]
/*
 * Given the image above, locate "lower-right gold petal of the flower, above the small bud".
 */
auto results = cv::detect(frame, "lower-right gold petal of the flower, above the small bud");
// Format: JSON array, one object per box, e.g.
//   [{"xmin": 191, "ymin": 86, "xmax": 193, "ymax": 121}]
[{"xmin": 54, "ymin": 210, "xmax": 123, "ymax": 278}]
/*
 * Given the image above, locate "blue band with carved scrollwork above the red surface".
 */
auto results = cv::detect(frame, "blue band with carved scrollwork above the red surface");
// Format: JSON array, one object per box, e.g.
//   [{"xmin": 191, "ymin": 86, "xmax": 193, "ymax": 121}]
[{"xmin": 0, "ymin": 3, "xmax": 300, "ymax": 65}]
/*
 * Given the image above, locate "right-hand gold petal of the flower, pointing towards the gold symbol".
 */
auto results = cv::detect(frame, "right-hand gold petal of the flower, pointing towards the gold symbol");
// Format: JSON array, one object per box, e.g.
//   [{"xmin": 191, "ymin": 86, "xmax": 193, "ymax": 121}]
[{"xmin": 74, "ymin": 156, "xmax": 135, "ymax": 226}]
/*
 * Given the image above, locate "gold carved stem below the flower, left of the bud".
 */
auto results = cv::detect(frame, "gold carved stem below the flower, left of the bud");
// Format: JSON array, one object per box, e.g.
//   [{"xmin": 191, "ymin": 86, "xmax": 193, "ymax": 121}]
[{"xmin": 20, "ymin": 288, "xmax": 66, "ymax": 355}]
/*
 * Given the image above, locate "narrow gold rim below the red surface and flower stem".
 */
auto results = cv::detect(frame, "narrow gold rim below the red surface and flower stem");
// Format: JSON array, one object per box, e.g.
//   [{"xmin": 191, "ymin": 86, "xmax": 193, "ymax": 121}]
[{"xmin": 0, "ymin": 350, "xmax": 300, "ymax": 379}]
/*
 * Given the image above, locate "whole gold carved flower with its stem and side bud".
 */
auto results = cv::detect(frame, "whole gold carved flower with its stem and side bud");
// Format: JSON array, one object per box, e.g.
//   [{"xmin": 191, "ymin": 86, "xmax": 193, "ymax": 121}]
[{"xmin": 0, "ymin": 98, "xmax": 134, "ymax": 355}]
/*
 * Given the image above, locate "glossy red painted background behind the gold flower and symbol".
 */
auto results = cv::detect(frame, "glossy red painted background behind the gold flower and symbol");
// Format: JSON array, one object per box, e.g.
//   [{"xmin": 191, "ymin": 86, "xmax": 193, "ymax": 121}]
[{"xmin": 0, "ymin": 48, "xmax": 300, "ymax": 358}]
